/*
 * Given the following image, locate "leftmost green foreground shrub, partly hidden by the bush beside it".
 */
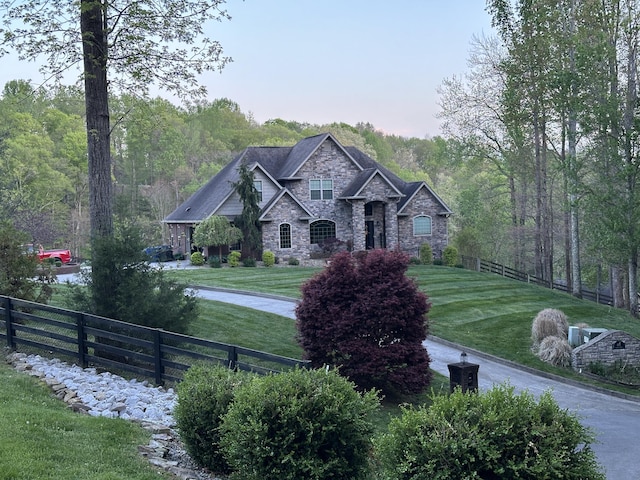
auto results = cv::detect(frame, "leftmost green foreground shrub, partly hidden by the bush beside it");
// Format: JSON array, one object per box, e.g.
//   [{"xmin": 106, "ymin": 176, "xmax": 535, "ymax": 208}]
[{"xmin": 178, "ymin": 364, "xmax": 255, "ymax": 473}]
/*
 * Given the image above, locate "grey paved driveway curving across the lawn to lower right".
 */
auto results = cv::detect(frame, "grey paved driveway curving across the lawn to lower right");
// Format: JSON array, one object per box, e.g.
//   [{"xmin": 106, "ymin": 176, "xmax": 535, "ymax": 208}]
[{"xmin": 198, "ymin": 288, "xmax": 640, "ymax": 480}]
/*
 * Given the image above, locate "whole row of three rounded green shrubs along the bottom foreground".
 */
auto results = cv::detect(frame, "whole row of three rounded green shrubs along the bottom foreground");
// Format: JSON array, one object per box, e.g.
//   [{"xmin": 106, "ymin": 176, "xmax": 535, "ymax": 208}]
[{"xmin": 175, "ymin": 365, "xmax": 605, "ymax": 480}]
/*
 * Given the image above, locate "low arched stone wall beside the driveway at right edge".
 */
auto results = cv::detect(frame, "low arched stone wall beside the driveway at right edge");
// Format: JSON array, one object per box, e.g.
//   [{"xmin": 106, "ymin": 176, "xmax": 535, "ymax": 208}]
[{"xmin": 571, "ymin": 330, "xmax": 640, "ymax": 371}]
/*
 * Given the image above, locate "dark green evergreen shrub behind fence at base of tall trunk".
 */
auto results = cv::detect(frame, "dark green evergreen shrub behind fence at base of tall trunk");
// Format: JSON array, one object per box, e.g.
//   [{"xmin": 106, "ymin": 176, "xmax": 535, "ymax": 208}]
[{"xmin": 68, "ymin": 226, "xmax": 198, "ymax": 333}]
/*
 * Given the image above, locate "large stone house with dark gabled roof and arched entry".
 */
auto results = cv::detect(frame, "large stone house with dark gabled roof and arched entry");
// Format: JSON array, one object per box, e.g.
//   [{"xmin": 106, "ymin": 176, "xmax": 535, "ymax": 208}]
[{"xmin": 164, "ymin": 133, "xmax": 452, "ymax": 259}]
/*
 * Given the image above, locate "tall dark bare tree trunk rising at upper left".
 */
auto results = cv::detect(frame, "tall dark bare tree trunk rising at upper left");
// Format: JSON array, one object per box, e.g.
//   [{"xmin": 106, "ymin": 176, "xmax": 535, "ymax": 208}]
[{"xmin": 80, "ymin": 0, "xmax": 113, "ymax": 238}]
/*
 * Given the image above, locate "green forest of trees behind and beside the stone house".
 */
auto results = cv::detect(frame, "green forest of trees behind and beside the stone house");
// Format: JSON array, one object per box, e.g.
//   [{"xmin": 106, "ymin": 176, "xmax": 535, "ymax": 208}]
[{"xmin": 0, "ymin": 0, "xmax": 640, "ymax": 312}]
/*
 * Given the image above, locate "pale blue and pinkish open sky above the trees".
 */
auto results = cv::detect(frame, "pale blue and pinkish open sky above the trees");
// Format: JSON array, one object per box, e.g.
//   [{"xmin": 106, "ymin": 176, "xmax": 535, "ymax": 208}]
[{"xmin": 0, "ymin": 0, "xmax": 493, "ymax": 138}]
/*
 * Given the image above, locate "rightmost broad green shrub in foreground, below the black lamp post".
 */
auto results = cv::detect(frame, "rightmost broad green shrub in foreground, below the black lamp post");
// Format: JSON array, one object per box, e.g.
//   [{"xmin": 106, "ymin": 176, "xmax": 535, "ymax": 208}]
[{"xmin": 375, "ymin": 385, "xmax": 605, "ymax": 480}]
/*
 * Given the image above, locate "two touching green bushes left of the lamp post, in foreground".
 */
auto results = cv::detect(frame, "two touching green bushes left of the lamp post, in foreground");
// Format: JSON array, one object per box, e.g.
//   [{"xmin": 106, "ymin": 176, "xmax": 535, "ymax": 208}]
[{"xmin": 174, "ymin": 366, "xmax": 379, "ymax": 480}]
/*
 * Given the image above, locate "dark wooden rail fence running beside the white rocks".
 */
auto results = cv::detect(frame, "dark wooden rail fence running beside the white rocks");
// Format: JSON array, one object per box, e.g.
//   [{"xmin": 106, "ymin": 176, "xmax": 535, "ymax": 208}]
[{"xmin": 0, "ymin": 296, "xmax": 308, "ymax": 385}]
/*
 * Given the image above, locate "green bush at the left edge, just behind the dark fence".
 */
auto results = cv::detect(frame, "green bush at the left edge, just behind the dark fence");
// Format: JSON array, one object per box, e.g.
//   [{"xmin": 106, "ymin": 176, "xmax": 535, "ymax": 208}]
[{"xmin": 0, "ymin": 221, "xmax": 55, "ymax": 303}]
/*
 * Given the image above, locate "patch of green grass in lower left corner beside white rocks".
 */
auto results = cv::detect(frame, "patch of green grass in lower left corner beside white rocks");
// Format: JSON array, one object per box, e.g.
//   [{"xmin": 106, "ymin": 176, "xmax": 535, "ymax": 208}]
[{"xmin": 0, "ymin": 363, "xmax": 170, "ymax": 480}]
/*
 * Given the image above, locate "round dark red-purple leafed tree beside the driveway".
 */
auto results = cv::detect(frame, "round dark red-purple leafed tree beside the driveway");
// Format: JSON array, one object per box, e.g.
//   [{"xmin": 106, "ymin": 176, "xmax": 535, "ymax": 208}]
[{"xmin": 296, "ymin": 250, "xmax": 431, "ymax": 394}]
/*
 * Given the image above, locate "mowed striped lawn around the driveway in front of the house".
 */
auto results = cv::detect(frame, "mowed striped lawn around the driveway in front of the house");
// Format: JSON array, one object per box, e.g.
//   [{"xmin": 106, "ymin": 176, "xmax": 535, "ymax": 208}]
[{"xmin": 171, "ymin": 266, "xmax": 640, "ymax": 394}]
